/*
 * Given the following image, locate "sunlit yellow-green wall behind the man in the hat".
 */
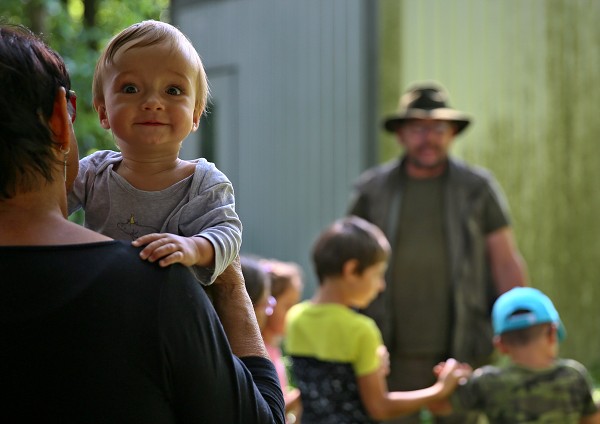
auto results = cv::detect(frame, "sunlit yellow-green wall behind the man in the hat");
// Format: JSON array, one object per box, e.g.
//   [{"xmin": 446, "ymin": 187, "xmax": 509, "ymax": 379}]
[{"xmin": 378, "ymin": 0, "xmax": 600, "ymax": 375}]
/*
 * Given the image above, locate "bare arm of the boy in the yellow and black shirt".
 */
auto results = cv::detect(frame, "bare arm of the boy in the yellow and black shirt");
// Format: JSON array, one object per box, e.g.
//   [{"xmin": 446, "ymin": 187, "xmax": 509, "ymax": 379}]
[{"xmin": 358, "ymin": 359, "xmax": 462, "ymax": 420}]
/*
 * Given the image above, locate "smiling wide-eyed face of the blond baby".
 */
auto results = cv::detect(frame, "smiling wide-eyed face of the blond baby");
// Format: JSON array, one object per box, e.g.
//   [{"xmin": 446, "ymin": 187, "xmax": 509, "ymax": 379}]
[{"xmin": 96, "ymin": 43, "xmax": 200, "ymax": 149}]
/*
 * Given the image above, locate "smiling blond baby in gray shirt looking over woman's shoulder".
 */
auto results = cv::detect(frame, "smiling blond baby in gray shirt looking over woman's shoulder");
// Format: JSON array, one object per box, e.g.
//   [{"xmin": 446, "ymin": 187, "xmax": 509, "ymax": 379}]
[{"xmin": 69, "ymin": 20, "xmax": 242, "ymax": 284}]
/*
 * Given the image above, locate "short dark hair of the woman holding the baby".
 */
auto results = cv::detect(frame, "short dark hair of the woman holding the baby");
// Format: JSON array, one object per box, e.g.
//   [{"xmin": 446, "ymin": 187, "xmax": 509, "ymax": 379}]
[{"xmin": 0, "ymin": 24, "xmax": 71, "ymax": 201}]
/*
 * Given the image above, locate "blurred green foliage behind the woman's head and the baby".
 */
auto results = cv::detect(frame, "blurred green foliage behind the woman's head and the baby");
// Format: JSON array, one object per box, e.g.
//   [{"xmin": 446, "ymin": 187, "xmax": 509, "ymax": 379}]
[{"xmin": 0, "ymin": 0, "xmax": 169, "ymax": 156}]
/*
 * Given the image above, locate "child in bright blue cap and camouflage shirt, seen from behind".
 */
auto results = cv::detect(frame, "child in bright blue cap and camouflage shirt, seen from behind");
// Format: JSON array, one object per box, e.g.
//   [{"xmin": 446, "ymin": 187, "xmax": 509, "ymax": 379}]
[{"xmin": 437, "ymin": 287, "xmax": 600, "ymax": 424}]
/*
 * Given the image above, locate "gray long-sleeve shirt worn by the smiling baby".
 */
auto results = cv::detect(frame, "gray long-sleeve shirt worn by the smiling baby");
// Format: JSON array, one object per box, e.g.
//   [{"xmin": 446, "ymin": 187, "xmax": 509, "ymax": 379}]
[{"xmin": 69, "ymin": 150, "xmax": 242, "ymax": 284}]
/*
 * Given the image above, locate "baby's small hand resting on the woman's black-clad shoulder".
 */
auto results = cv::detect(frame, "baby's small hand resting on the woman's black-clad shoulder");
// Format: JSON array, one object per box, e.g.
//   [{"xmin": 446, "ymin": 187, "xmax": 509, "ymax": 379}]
[{"xmin": 132, "ymin": 233, "xmax": 215, "ymax": 267}]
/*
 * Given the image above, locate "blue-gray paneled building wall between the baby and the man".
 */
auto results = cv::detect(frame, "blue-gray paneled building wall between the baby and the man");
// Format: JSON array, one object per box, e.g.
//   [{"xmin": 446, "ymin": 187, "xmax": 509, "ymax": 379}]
[{"xmin": 171, "ymin": 0, "xmax": 377, "ymax": 296}]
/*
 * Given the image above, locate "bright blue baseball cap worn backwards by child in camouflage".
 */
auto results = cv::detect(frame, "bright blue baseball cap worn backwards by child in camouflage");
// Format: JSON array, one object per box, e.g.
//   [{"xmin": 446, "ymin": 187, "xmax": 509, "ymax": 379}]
[{"xmin": 492, "ymin": 287, "xmax": 566, "ymax": 340}]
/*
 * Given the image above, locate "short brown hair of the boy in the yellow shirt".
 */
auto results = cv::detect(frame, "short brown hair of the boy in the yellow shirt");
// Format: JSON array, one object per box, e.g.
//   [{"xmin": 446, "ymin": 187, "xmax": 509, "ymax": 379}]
[{"xmin": 312, "ymin": 216, "xmax": 390, "ymax": 284}]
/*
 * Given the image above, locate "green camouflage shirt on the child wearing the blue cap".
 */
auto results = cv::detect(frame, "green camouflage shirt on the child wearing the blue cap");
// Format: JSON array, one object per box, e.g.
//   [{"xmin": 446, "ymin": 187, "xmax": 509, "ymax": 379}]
[{"xmin": 451, "ymin": 359, "xmax": 596, "ymax": 424}]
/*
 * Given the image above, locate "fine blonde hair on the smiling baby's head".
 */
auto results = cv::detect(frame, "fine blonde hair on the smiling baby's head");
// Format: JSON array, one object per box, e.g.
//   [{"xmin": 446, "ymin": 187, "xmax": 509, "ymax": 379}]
[{"xmin": 92, "ymin": 20, "xmax": 209, "ymax": 115}]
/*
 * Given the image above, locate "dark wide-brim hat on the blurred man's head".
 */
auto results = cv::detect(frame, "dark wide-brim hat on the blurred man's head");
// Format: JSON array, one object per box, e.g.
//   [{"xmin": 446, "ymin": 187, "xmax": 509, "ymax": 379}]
[{"xmin": 383, "ymin": 83, "xmax": 471, "ymax": 134}]
